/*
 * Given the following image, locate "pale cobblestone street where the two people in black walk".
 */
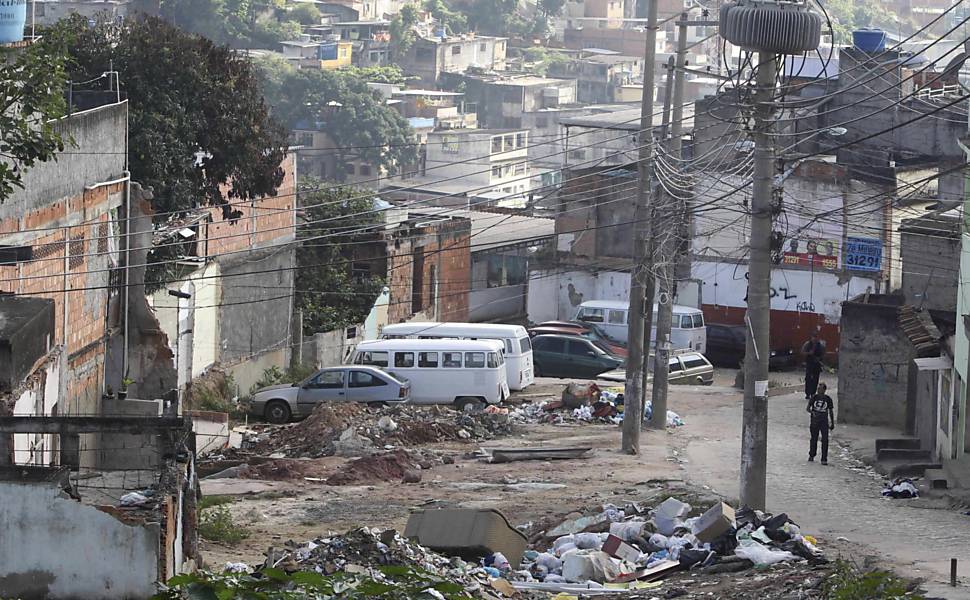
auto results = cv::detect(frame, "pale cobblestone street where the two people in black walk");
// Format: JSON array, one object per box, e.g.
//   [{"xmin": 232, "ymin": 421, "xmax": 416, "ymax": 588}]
[{"xmin": 671, "ymin": 378, "xmax": 970, "ymax": 598}]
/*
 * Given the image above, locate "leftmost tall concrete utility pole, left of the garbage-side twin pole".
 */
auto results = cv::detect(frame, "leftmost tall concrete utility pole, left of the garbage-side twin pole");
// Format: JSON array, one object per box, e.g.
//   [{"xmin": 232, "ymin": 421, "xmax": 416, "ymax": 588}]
[{"xmin": 622, "ymin": 0, "xmax": 659, "ymax": 454}]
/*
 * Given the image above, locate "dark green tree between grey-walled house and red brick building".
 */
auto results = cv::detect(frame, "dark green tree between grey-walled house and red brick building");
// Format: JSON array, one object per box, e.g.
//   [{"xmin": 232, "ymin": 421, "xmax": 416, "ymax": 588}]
[{"xmin": 296, "ymin": 180, "xmax": 384, "ymax": 334}]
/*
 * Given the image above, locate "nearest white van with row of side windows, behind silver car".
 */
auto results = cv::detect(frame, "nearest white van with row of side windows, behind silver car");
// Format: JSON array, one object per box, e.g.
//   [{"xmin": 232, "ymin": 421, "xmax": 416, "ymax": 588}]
[{"xmin": 351, "ymin": 339, "xmax": 509, "ymax": 410}]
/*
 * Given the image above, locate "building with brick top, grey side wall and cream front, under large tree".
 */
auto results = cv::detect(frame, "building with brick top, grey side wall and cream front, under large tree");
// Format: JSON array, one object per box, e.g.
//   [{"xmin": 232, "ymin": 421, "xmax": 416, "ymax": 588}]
[{"xmin": 150, "ymin": 153, "xmax": 297, "ymax": 390}]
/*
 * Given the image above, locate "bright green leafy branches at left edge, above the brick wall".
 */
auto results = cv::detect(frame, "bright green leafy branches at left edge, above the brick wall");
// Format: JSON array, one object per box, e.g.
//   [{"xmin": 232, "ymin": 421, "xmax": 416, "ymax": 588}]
[{"xmin": 0, "ymin": 40, "xmax": 71, "ymax": 204}]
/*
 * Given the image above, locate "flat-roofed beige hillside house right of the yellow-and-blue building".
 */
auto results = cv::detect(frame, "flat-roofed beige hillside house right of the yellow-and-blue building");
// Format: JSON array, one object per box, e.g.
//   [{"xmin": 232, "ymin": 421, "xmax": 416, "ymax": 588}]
[{"xmin": 395, "ymin": 33, "xmax": 508, "ymax": 88}]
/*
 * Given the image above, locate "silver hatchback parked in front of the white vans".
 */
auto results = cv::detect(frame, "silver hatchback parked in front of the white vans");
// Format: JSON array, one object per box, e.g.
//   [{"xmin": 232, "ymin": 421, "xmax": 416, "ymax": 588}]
[{"xmin": 249, "ymin": 365, "xmax": 411, "ymax": 423}]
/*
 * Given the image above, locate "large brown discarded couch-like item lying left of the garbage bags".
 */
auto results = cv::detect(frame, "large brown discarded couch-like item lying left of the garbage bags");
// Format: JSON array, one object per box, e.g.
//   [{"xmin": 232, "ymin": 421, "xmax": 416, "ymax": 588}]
[{"xmin": 404, "ymin": 508, "xmax": 528, "ymax": 566}]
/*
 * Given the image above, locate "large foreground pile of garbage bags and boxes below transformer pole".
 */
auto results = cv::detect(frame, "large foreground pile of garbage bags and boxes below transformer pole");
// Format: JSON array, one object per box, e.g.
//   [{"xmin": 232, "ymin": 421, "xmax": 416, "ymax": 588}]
[{"xmin": 502, "ymin": 497, "xmax": 827, "ymax": 591}]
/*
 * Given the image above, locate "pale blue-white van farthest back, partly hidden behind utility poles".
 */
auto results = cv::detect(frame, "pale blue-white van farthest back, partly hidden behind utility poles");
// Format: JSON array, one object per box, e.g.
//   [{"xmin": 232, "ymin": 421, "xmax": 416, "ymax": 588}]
[{"xmin": 576, "ymin": 300, "xmax": 707, "ymax": 353}]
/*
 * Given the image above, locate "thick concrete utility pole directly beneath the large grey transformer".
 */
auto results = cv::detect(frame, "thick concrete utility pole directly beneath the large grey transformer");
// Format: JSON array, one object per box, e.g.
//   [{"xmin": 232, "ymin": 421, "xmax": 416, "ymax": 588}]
[{"xmin": 741, "ymin": 51, "xmax": 778, "ymax": 510}]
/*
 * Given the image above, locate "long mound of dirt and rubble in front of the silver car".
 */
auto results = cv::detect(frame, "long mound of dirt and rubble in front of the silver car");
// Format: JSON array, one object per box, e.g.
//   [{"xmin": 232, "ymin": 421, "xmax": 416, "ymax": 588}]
[{"xmin": 233, "ymin": 403, "xmax": 513, "ymax": 458}]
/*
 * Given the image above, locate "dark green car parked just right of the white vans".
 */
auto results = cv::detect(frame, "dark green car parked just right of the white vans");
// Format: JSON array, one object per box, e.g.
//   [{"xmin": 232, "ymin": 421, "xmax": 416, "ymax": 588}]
[{"xmin": 532, "ymin": 335, "xmax": 623, "ymax": 379}]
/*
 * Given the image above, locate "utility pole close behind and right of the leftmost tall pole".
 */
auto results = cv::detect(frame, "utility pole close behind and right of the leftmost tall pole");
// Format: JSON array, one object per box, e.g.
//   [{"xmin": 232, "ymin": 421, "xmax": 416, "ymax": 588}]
[{"xmin": 650, "ymin": 12, "xmax": 688, "ymax": 429}]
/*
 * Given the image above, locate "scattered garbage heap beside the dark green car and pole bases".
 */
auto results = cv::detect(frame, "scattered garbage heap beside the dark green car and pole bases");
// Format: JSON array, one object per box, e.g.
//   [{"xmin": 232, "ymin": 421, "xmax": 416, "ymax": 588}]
[{"xmin": 509, "ymin": 383, "xmax": 685, "ymax": 427}]
